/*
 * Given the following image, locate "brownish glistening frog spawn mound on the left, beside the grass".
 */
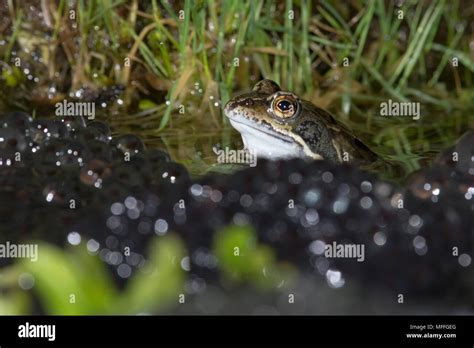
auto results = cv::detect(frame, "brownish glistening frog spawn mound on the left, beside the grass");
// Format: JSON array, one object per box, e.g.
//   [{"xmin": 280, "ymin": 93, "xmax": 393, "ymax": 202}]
[{"xmin": 0, "ymin": 113, "xmax": 174, "ymax": 268}]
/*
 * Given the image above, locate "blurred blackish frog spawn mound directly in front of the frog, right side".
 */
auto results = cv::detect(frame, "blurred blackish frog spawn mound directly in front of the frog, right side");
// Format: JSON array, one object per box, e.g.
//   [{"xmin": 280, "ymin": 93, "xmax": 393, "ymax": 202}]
[{"xmin": 184, "ymin": 161, "xmax": 473, "ymax": 300}]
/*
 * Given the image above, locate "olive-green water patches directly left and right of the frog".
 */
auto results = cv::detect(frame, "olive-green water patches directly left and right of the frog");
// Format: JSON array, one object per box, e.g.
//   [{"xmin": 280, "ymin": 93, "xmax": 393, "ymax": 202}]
[{"xmin": 112, "ymin": 110, "xmax": 467, "ymax": 183}]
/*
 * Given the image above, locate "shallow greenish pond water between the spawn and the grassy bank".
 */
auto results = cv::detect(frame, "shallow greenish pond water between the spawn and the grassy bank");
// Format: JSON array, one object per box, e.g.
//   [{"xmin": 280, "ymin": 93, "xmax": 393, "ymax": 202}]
[{"xmin": 0, "ymin": 98, "xmax": 466, "ymax": 182}]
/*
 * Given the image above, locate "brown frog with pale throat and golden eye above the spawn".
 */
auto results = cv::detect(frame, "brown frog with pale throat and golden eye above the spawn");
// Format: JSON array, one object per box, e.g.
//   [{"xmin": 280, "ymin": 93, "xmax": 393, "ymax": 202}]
[{"xmin": 224, "ymin": 79, "xmax": 379, "ymax": 165}]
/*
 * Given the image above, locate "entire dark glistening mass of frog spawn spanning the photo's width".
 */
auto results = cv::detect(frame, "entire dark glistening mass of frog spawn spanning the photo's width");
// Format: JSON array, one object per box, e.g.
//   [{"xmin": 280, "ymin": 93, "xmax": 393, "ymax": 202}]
[{"xmin": 0, "ymin": 113, "xmax": 474, "ymax": 308}]
